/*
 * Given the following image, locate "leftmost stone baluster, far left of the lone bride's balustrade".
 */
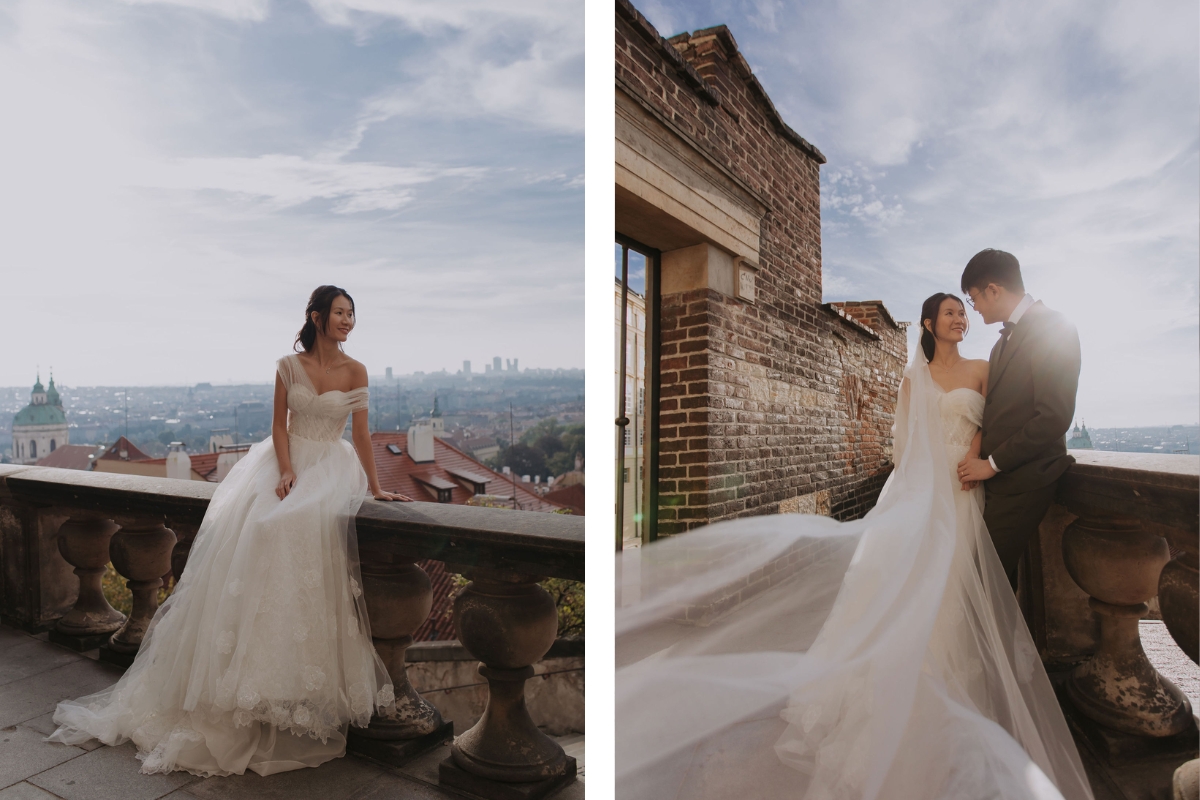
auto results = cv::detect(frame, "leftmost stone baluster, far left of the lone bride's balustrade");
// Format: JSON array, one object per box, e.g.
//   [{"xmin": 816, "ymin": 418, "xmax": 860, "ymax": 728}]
[{"xmin": 50, "ymin": 515, "xmax": 125, "ymax": 650}]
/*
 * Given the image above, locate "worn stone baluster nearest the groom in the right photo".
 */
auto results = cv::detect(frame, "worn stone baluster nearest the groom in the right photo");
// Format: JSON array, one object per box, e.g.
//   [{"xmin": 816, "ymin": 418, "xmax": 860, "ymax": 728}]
[{"xmin": 1062, "ymin": 517, "xmax": 1194, "ymax": 738}]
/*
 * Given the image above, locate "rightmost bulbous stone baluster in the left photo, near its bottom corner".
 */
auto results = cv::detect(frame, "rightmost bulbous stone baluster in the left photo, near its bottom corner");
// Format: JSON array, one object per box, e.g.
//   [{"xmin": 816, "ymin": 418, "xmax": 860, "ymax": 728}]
[{"xmin": 439, "ymin": 567, "xmax": 576, "ymax": 796}]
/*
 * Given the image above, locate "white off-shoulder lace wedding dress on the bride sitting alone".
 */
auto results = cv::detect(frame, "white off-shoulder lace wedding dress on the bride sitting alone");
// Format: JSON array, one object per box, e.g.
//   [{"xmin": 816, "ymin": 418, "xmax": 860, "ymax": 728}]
[{"xmin": 49, "ymin": 355, "xmax": 395, "ymax": 776}]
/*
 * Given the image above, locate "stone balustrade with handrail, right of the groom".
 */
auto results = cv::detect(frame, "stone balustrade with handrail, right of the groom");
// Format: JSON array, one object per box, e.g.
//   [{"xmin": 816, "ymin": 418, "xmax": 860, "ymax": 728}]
[{"xmin": 1025, "ymin": 450, "xmax": 1200, "ymax": 758}]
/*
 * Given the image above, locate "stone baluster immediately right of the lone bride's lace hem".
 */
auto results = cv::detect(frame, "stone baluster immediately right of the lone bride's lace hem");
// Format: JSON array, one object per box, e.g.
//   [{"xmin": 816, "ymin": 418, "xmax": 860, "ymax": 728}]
[{"xmin": 350, "ymin": 553, "xmax": 454, "ymax": 765}]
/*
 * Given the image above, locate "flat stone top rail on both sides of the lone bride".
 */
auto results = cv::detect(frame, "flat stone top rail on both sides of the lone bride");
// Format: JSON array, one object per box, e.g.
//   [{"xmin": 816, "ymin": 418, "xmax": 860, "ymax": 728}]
[{"xmin": 0, "ymin": 464, "xmax": 583, "ymax": 581}]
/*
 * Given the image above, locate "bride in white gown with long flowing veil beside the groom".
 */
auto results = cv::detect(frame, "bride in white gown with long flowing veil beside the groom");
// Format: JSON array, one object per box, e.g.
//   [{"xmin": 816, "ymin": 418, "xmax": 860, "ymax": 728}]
[{"xmin": 617, "ymin": 295, "xmax": 1092, "ymax": 800}]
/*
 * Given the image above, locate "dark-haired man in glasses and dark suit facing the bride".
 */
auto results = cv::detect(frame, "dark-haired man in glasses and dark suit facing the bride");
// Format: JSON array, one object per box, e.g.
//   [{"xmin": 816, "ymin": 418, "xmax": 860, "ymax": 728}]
[{"xmin": 958, "ymin": 248, "xmax": 1079, "ymax": 591}]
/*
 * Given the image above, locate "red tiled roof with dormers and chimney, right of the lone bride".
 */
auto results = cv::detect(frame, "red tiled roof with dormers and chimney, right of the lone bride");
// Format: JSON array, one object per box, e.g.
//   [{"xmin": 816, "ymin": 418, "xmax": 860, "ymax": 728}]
[{"xmin": 371, "ymin": 431, "xmax": 565, "ymax": 511}]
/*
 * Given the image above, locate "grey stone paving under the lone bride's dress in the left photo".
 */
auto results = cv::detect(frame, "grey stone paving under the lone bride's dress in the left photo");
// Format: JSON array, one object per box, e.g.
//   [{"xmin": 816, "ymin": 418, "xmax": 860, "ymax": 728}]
[{"xmin": 0, "ymin": 626, "xmax": 584, "ymax": 800}]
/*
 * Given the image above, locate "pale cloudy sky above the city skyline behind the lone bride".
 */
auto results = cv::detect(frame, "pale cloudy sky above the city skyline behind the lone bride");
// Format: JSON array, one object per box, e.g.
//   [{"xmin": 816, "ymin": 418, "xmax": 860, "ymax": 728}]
[{"xmin": 0, "ymin": 0, "xmax": 583, "ymax": 386}]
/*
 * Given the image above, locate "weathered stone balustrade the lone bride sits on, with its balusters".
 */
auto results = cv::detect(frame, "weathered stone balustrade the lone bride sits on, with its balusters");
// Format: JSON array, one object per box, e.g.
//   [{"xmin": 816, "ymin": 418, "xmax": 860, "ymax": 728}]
[{"xmin": 0, "ymin": 465, "xmax": 583, "ymax": 798}]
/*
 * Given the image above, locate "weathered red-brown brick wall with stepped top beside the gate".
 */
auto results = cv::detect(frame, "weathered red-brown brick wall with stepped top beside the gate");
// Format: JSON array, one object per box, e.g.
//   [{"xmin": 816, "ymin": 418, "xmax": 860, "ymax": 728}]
[{"xmin": 617, "ymin": 0, "xmax": 906, "ymax": 534}]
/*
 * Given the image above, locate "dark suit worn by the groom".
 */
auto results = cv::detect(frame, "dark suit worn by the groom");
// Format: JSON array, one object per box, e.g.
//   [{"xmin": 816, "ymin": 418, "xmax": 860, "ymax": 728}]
[{"xmin": 980, "ymin": 302, "xmax": 1080, "ymax": 590}]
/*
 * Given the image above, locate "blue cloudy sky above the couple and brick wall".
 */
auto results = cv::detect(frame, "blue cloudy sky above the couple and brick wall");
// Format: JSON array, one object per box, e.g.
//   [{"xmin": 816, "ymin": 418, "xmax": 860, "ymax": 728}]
[{"xmin": 636, "ymin": 0, "xmax": 1200, "ymax": 427}]
